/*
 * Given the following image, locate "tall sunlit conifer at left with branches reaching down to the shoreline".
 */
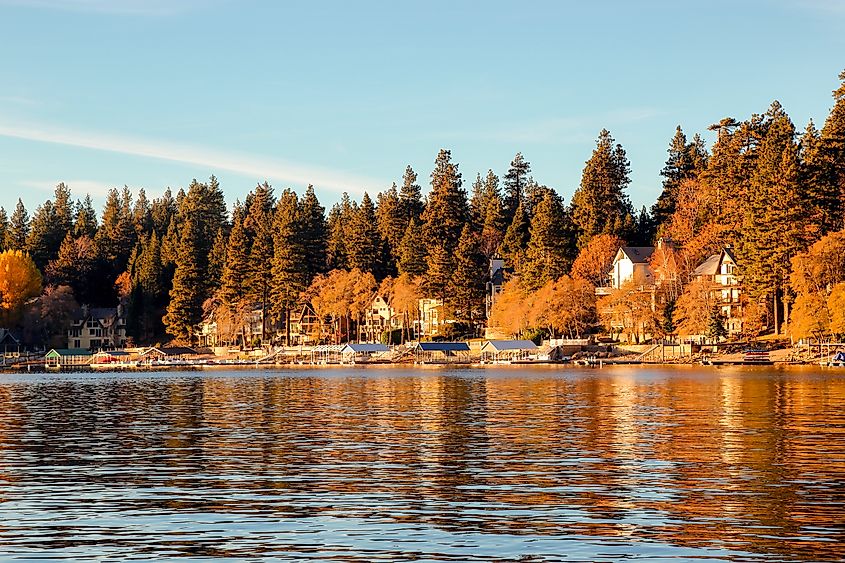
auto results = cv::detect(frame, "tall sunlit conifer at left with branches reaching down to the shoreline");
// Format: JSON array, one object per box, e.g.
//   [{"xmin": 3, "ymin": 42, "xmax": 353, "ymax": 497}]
[{"xmin": 163, "ymin": 214, "xmax": 208, "ymax": 344}]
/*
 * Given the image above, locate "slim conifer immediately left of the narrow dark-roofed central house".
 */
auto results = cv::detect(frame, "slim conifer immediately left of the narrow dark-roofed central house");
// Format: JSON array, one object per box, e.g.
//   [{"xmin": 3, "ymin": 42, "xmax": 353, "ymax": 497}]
[{"xmin": 449, "ymin": 225, "xmax": 486, "ymax": 322}]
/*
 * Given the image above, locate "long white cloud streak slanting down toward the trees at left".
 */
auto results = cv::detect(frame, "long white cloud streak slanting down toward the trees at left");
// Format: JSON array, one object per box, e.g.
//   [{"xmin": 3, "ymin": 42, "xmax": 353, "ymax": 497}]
[{"xmin": 0, "ymin": 123, "xmax": 385, "ymax": 194}]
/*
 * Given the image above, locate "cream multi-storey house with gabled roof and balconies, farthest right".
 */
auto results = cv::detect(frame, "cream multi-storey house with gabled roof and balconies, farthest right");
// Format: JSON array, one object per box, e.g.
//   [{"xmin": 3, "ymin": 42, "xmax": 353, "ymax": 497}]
[{"xmin": 692, "ymin": 246, "xmax": 744, "ymax": 336}]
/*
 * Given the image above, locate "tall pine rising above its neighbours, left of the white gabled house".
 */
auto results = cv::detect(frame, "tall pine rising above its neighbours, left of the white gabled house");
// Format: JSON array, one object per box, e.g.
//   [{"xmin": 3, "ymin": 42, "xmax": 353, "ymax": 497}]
[{"xmin": 572, "ymin": 129, "xmax": 634, "ymax": 248}]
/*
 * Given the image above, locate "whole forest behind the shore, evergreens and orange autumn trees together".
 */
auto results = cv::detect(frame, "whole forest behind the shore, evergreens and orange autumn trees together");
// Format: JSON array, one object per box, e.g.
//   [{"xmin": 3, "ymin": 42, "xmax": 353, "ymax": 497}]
[{"xmin": 0, "ymin": 72, "xmax": 845, "ymax": 344}]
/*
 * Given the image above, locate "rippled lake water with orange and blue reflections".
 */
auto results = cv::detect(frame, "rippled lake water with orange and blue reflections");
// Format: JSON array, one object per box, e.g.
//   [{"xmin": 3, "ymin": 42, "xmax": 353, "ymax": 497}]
[{"xmin": 0, "ymin": 368, "xmax": 845, "ymax": 561}]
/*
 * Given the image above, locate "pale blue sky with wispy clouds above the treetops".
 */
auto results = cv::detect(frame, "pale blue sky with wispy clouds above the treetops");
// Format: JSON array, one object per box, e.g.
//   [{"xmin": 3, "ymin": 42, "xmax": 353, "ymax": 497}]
[{"xmin": 0, "ymin": 0, "xmax": 845, "ymax": 217}]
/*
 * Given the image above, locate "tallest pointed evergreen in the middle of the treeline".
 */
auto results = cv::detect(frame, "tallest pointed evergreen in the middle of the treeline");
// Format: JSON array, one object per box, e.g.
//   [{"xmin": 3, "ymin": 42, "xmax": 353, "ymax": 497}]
[{"xmin": 421, "ymin": 149, "xmax": 469, "ymax": 254}]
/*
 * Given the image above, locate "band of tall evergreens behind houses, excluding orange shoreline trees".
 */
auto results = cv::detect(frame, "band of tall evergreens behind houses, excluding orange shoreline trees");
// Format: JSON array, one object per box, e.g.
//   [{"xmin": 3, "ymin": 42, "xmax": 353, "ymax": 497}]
[{"xmin": 0, "ymin": 68, "xmax": 845, "ymax": 342}]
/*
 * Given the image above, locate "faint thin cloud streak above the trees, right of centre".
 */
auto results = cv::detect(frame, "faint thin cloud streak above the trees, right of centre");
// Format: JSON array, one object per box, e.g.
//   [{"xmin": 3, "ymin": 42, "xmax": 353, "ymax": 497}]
[{"xmin": 443, "ymin": 108, "xmax": 660, "ymax": 143}]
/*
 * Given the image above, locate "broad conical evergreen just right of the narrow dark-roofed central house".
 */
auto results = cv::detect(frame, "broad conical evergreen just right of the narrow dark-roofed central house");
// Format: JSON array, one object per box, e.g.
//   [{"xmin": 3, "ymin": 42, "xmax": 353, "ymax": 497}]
[{"xmin": 518, "ymin": 193, "xmax": 573, "ymax": 291}]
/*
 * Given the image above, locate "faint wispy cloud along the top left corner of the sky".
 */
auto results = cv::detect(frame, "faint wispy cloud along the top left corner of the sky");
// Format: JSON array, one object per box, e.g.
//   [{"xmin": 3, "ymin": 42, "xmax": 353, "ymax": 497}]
[{"xmin": 0, "ymin": 0, "xmax": 219, "ymax": 16}]
